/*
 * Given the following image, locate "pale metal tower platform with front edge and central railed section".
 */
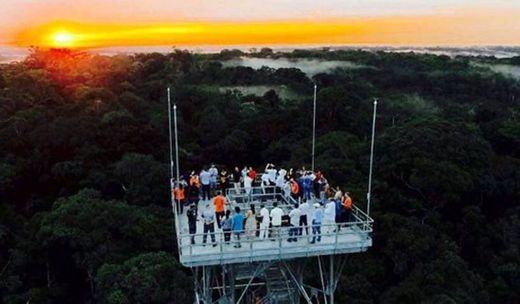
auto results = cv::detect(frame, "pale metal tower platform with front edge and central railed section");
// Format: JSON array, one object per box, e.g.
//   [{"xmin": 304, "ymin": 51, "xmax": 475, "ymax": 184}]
[{"xmin": 176, "ymin": 188, "xmax": 373, "ymax": 267}]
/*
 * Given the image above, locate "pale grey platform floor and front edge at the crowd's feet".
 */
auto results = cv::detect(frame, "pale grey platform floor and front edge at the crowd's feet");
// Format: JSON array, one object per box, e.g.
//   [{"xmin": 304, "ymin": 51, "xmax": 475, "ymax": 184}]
[{"xmin": 178, "ymin": 197, "xmax": 372, "ymax": 267}]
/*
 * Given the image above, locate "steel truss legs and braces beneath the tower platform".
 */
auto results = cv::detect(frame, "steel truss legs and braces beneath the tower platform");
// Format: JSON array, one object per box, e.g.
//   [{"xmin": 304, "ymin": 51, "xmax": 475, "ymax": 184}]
[{"xmin": 192, "ymin": 255, "xmax": 347, "ymax": 304}]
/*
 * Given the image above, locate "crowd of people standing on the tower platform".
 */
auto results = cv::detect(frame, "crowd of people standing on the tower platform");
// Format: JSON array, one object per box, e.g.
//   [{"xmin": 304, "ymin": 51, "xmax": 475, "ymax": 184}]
[{"xmin": 172, "ymin": 164, "xmax": 352, "ymax": 248}]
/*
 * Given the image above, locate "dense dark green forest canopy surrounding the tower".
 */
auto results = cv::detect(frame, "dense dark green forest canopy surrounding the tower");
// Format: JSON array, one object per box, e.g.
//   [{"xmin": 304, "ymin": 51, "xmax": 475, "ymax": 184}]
[{"xmin": 0, "ymin": 49, "xmax": 520, "ymax": 303}]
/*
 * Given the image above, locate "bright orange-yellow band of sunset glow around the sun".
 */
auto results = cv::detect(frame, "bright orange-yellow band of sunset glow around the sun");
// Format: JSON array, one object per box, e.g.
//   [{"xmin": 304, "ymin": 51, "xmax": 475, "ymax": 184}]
[{"xmin": 11, "ymin": 10, "xmax": 520, "ymax": 48}]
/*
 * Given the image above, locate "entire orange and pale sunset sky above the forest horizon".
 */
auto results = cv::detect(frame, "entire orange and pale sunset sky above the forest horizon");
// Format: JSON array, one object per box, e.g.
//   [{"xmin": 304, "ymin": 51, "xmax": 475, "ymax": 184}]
[{"xmin": 4, "ymin": 0, "xmax": 520, "ymax": 48}]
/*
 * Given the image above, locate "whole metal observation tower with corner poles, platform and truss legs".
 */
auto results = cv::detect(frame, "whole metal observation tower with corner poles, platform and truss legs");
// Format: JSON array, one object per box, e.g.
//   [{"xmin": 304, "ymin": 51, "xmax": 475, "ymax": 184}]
[{"xmin": 168, "ymin": 88, "xmax": 377, "ymax": 304}]
